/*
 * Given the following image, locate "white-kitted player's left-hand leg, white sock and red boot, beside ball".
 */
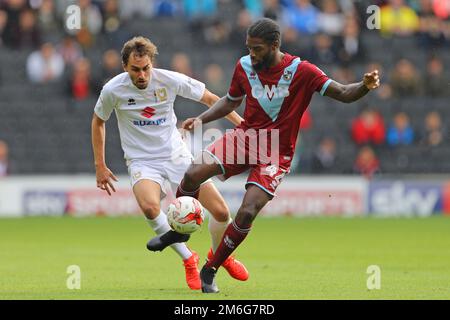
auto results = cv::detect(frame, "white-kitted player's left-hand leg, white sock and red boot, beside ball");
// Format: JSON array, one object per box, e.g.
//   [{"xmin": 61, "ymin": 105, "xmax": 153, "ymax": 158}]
[{"xmin": 133, "ymin": 179, "xmax": 200, "ymax": 290}]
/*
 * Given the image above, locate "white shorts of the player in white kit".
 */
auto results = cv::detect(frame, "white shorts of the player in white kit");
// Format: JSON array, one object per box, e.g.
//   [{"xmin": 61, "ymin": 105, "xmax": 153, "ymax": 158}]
[{"xmin": 127, "ymin": 150, "xmax": 212, "ymax": 199}]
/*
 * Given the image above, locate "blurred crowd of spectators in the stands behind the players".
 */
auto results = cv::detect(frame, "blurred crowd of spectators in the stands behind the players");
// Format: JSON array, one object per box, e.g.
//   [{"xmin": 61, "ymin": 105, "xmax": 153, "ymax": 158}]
[{"xmin": 0, "ymin": 0, "xmax": 450, "ymax": 176}]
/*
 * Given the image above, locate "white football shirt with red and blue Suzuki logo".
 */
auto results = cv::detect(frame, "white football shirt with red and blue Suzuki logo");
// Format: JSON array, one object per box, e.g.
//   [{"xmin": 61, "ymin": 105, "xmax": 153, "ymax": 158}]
[{"xmin": 94, "ymin": 68, "xmax": 205, "ymax": 160}]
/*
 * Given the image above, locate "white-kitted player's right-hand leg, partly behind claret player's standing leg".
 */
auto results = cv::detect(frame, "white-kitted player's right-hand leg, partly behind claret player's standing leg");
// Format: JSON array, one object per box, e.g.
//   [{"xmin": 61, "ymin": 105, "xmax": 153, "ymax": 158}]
[{"xmin": 199, "ymin": 182, "xmax": 249, "ymax": 281}]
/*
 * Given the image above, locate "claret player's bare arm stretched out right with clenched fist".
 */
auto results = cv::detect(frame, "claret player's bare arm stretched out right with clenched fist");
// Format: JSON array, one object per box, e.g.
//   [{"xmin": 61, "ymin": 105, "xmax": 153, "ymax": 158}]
[{"xmin": 325, "ymin": 70, "xmax": 380, "ymax": 103}]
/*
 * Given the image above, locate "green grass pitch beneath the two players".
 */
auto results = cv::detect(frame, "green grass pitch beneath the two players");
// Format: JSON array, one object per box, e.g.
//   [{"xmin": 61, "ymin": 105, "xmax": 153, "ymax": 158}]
[{"xmin": 0, "ymin": 217, "xmax": 450, "ymax": 300}]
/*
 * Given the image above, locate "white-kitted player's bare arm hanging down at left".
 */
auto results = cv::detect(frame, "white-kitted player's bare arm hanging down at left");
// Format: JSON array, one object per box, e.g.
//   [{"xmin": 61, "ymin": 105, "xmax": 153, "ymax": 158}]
[{"xmin": 91, "ymin": 113, "xmax": 118, "ymax": 195}]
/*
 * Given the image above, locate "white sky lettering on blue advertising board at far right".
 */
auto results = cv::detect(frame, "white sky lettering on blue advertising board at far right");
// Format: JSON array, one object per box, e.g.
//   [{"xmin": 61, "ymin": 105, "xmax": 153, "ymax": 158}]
[{"xmin": 369, "ymin": 181, "xmax": 442, "ymax": 217}]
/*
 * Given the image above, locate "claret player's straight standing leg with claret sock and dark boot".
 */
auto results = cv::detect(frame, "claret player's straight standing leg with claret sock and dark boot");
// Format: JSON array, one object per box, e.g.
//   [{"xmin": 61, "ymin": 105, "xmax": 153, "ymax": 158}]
[{"xmin": 200, "ymin": 185, "xmax": 273, "ymax": 293}]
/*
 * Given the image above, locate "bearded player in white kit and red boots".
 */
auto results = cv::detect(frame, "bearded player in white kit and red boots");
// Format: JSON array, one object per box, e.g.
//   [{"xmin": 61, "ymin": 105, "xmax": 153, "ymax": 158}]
[{"xmin": 92, "ymin": 37, "xmax": 248, "ymax": 290}]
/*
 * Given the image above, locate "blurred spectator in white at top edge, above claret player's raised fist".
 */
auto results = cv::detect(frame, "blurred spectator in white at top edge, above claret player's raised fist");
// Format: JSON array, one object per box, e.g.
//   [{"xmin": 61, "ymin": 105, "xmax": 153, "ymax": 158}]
[{"xmin": 318, "ymin": 0, "xmax": 344, "ymax": 36}]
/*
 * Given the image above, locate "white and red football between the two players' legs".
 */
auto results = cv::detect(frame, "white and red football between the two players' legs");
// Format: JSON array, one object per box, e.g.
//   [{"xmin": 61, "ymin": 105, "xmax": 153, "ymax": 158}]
[{"xmin": 167, "ymin": 197, "xmax": 205, "ymax": 234}]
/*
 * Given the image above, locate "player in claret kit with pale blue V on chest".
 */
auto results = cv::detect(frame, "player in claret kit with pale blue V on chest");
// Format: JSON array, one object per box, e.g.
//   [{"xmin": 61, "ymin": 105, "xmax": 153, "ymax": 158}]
[{"xmin": 150, "ymin": 18, "xmax": 379, "ymax": 293}]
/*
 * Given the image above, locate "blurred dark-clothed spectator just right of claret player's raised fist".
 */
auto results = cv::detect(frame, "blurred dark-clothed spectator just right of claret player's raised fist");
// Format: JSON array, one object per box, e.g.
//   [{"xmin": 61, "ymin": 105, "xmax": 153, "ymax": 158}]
[{"xmin": 390, "ymin": 59, "xmax": 422, "ymax": 97}]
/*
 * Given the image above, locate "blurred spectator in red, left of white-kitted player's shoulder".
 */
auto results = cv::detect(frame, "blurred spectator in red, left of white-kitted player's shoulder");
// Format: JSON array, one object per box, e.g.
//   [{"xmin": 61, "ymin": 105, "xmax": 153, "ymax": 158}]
[{"xmin": 69, "ymin": 58, "xmax": 95, "ymax": 101}]
